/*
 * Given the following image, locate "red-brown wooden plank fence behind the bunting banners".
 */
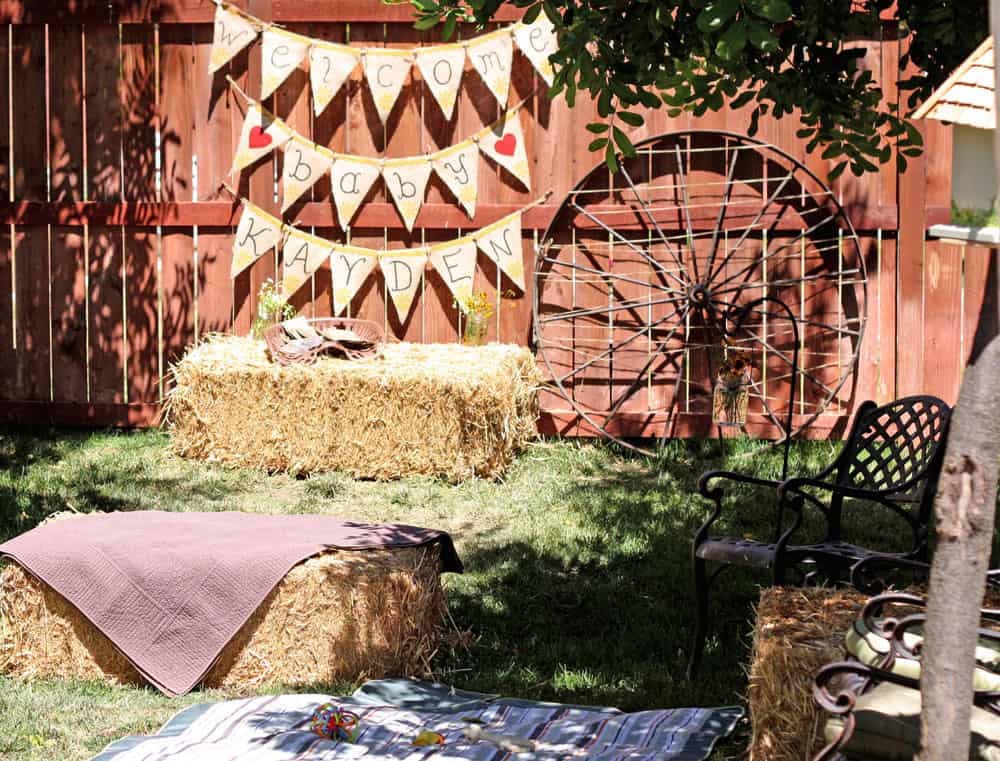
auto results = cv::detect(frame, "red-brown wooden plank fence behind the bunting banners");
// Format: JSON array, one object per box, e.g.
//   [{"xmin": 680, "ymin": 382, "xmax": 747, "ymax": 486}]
[{"xmin": 0, "ymin": 0, "xmax": 988, "ymax": 431}]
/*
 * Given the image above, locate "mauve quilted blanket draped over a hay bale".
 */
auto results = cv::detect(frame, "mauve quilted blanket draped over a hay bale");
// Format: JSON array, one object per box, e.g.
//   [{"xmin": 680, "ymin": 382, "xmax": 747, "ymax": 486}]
[{"xmin": 0, "ymin": 511, "xmax": 462, "ymax": 695}]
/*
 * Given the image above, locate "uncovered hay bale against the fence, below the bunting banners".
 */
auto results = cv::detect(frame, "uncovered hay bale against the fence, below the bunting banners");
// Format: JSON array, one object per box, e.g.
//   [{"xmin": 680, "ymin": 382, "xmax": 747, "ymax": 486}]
[{"xmin": 165, "ymin": 336, "xmax": 541, "ymax": 481}]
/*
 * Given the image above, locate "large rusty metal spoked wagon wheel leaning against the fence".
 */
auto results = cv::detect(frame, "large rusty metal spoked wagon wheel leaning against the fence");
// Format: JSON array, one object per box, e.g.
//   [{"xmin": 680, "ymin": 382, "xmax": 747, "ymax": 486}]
[{"xmin": 533, "ymin": 131, "xmax": 866, "ymax": 451}]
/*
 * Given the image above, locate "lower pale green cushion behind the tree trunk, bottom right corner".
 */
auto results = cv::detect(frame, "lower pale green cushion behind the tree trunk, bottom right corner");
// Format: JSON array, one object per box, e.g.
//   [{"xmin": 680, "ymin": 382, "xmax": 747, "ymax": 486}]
[{"xmin": 824, "ymin": 682, "xmax": 1000, "ymax": 761}]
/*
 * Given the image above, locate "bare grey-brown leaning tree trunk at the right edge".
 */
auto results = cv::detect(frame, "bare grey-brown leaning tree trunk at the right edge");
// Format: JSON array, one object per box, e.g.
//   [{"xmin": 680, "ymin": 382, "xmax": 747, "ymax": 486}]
[{"xmin": 919, "ymin": 7, "xmax": 1000, "ymax": 761}]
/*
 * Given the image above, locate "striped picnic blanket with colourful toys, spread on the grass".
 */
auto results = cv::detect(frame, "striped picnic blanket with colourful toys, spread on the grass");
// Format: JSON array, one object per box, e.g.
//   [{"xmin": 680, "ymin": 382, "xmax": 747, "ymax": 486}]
[{"xmin": 93, "ymin": 688, "xmax": 742, "ymax": 761}]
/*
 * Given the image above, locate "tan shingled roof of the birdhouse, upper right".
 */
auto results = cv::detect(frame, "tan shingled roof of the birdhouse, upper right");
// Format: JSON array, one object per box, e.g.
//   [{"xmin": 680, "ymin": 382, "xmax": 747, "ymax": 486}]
[{"xmin": 913, "ymin": 37, "xmax": 997, "ymax": 129}]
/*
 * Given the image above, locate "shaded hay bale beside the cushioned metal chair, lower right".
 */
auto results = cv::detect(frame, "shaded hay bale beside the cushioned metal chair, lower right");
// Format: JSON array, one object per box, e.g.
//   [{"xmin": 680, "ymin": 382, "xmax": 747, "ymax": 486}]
[{"xmin": 747, "ymin": 587, "xmax": 1000, "ymax": 761}]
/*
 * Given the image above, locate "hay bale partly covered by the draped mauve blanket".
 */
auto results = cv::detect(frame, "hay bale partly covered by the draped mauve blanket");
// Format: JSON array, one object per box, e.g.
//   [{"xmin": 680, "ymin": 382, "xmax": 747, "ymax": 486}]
[{"xmin": 0, "ymin": 545, "xmax": 445, "ymax": 692}]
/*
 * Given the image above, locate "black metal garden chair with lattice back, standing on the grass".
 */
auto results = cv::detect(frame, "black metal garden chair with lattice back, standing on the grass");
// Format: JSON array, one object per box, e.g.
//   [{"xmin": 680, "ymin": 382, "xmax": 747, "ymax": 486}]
[{"xmin": 688, "ymin": 396, "xmax": 951, "ymax": 675}]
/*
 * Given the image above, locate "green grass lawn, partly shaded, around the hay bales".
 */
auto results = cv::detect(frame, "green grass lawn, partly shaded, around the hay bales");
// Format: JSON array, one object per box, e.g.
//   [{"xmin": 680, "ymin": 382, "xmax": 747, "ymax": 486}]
[{"xmin": 0, "ymin": 430, "xmax": 920, "ymax": 761}]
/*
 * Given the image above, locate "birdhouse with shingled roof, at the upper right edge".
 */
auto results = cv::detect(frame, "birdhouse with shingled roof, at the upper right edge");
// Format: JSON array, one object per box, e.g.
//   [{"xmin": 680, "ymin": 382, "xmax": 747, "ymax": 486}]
[{"xmin": 913, "ymin": 37, "xmax": 1000, "ymax": 245}]
